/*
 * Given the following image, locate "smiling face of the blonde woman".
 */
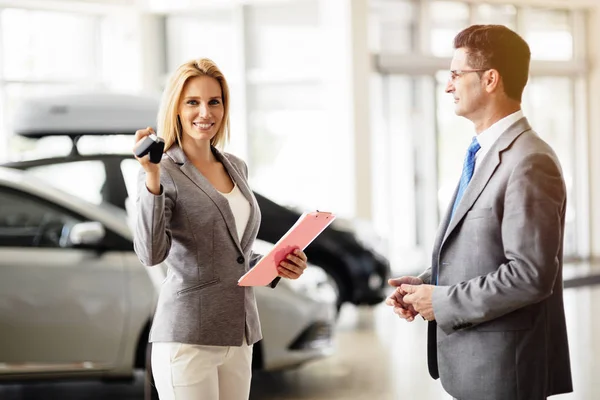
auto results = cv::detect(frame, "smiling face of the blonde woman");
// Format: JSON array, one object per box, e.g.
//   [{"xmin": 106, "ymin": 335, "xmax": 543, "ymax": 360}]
[{"xmin": 178, "ymin": 76, "xmax": 225, "ymax": 142}]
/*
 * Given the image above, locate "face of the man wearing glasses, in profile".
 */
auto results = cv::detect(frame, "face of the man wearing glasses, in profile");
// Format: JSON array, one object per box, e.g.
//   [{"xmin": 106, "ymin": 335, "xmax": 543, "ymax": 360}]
[{"xmin": 446, "ymin": 48, "xmax": 486, "ymax": 119}]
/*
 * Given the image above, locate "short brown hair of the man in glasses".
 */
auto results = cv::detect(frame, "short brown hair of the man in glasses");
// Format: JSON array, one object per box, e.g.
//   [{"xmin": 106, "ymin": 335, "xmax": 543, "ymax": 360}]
[{"xmin": 454, "ymin": 25, "xmax": 531, "ymax": 102}]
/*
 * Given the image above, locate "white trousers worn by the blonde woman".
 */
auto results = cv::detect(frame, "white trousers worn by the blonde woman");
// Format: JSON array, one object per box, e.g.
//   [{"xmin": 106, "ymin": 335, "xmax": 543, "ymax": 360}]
[{"xmin": 152, "ymin": 338, "xmax": 252, "ymax": 400}]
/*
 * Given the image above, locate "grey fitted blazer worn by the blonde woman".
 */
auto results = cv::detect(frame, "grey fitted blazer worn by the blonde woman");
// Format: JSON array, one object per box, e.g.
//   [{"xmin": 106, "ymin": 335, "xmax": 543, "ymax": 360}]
[{"xmin": 134, "ymin": 144, "xmax": 270, "ymax": 346}]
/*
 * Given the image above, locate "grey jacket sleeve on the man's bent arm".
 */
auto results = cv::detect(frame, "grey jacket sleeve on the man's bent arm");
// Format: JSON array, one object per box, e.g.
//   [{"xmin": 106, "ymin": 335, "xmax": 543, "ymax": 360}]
[{"xmin": 433, "ymin": 154, "xmax": 566, "ymax": 334}]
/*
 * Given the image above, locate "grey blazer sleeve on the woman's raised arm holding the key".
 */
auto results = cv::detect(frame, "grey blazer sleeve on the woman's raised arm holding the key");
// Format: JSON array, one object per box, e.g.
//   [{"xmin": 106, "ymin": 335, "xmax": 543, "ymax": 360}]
[{"xmin": 133, "ymin": 167, "xmax": 177, "ymax": 266}]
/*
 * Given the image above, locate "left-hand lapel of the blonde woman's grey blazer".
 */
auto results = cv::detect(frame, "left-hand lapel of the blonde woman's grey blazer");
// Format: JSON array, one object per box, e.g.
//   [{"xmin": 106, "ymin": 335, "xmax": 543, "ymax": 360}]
[{"xmin": 167, "ymin": 144, "xmax": 243, "ymax": 253}]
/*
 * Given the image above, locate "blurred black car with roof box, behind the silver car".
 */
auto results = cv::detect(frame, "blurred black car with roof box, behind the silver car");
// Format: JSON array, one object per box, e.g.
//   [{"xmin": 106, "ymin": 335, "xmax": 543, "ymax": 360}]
[{"xmin": 4, "ymin": 93, "xmax": 390, "ymax": 310}]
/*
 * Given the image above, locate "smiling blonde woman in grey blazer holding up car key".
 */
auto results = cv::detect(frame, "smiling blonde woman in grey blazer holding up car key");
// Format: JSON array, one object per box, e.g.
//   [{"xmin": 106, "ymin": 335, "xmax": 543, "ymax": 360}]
[{"xmin": 134, "ymin": 59, "xmax": 306, "ymax": 400}]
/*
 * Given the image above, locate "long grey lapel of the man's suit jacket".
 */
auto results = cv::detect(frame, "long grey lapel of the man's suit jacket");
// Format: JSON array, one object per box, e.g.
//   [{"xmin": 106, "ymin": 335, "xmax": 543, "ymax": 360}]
[{"xmin": 440, "ymin": 118, "xmax": 531, "ymax": 247}]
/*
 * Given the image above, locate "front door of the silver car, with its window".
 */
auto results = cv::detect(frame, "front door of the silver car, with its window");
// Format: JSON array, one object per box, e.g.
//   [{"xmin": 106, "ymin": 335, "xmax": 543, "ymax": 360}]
[{"xmin": 0, "ymin": 186, "xmax": 128, "ymax": 374}]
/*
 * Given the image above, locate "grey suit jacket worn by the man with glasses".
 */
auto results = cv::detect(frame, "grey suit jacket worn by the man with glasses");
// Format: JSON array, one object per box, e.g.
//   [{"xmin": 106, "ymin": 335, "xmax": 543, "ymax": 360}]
[{"xmin": 421, "ymin": 118, "xmax": 573, "ymax": 400}]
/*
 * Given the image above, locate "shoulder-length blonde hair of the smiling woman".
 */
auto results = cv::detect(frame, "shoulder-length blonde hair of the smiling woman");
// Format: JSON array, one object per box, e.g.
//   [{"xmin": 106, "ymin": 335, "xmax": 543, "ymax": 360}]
[{"xmin": 156, "ymin": 58, "xmax": 229, "ymax": 151}]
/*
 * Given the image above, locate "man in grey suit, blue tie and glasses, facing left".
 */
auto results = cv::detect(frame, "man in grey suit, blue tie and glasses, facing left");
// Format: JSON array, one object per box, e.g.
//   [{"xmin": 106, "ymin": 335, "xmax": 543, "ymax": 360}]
[{"xmin": 386, "ymin": 25, "xmax": 572, "ymax": 400}]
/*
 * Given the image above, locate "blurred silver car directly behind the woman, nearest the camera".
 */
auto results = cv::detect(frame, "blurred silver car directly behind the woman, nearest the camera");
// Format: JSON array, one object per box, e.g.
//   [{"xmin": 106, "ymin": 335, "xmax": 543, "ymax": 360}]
[{"xmin": 0, "ymin": 167, "xmax": 335, "ymax": 390}]
